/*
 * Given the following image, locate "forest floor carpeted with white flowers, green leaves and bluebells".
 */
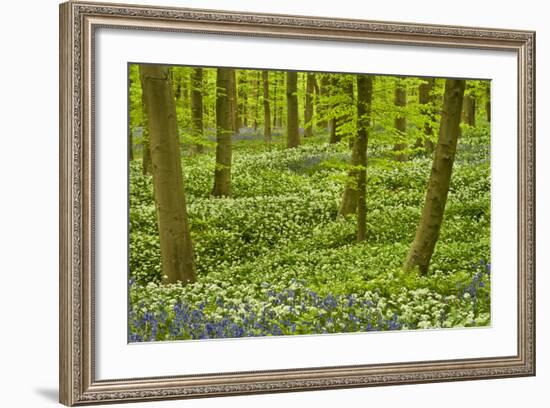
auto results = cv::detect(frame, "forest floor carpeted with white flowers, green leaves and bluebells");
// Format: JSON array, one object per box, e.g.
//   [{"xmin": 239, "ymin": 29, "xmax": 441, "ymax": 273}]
[{"xmin": 129, "ymin": 127, "xmax": 491, "ymax": 342}]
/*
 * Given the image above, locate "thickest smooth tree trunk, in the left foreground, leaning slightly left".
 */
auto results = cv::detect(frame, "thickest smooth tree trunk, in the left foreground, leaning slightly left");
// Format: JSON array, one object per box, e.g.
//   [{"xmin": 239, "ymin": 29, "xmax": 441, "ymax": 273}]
[{"xmin": 140, "ymin": 64, "xmax": 196, "ymax": 283}]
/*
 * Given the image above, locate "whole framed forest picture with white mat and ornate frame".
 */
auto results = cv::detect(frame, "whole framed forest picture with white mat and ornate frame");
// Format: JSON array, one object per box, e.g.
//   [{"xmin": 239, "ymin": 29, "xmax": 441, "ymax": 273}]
[{"xmin": 60, "ymin": 2, "xmax": 535, "ymax": 405}]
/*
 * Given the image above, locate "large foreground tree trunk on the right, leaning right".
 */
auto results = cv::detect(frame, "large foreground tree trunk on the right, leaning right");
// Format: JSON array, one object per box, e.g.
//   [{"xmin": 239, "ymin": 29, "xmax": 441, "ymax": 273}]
[{"xmin": 404, "ymin": 79, "xmax": 466, "ymax": 274}]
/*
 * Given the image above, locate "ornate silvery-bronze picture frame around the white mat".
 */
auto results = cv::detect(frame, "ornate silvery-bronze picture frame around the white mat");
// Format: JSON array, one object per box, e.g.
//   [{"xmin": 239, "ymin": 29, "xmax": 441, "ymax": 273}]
[{"xmin": 59, "ymin": 1, "xmax": 535, "ymax": 406}]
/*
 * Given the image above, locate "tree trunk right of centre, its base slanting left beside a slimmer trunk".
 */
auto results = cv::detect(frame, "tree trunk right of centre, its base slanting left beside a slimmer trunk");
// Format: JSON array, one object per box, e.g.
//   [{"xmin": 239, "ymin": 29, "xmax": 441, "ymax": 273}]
[{"xmin": 339, "ymin": 75, "xmax": 373, "ymax": 218}]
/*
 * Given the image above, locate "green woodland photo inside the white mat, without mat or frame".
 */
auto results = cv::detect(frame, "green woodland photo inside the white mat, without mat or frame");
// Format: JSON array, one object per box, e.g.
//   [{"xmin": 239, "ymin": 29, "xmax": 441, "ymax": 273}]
[{"xmin": 127, "ymin": 63, "xmax": 491, "ymax": 343}]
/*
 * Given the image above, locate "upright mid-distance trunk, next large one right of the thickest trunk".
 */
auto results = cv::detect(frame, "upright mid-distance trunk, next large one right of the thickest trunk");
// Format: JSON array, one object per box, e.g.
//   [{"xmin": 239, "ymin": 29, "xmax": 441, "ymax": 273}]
[{"xmin": 212, "ymin": 68, "xmax": 235, "ymax": 197}]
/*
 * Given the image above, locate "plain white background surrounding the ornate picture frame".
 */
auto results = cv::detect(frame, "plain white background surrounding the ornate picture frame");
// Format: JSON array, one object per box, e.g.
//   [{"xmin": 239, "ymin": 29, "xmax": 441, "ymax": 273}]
[{"xmin": 0, "ymin": 0, "xmax": 550, "ymax": 407}]
